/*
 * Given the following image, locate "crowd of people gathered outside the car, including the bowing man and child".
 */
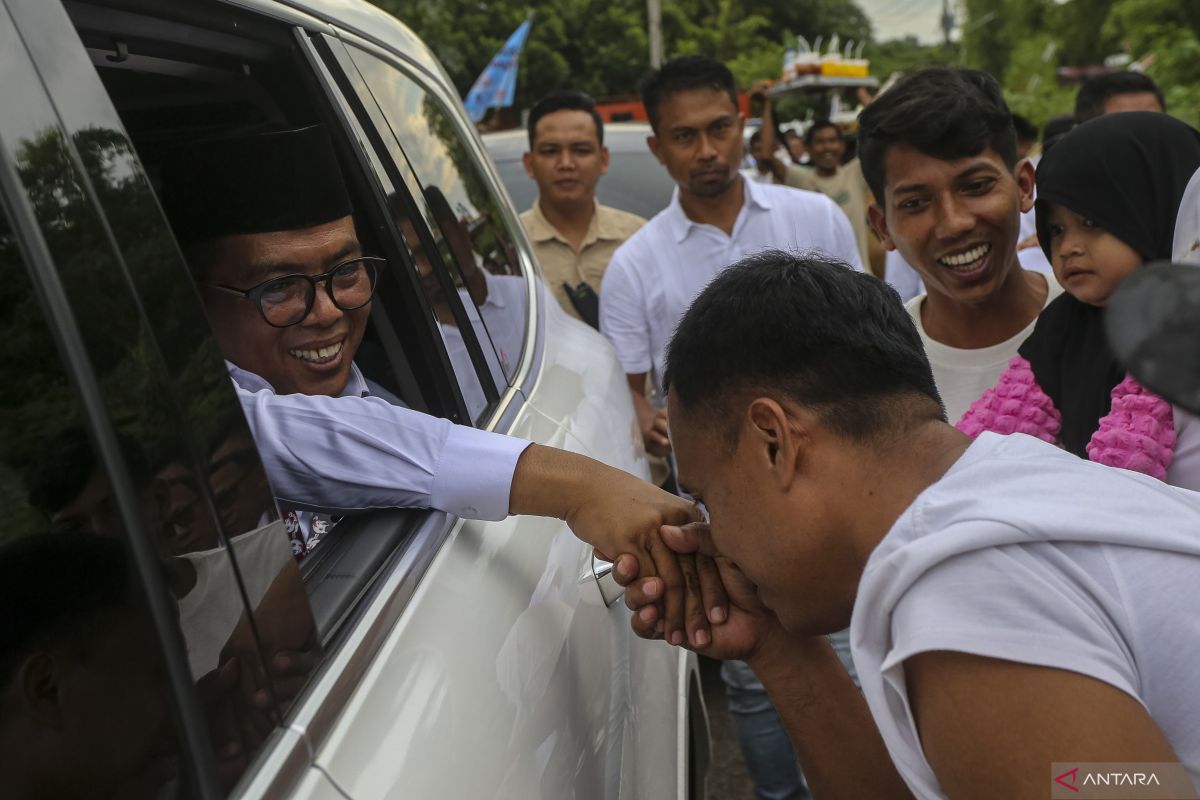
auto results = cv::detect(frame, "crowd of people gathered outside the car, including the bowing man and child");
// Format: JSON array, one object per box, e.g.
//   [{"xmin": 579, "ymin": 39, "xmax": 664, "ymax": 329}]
[{"xmin": 513, "ymin": 56, "xmax": 1200, "ymax": 800}]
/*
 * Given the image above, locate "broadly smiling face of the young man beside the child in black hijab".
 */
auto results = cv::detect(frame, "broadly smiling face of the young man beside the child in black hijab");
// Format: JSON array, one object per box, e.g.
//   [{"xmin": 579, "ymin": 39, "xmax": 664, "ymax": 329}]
[{"xmin": 870, "ymin": 144, "xmax": 1033, "ymax": 305}]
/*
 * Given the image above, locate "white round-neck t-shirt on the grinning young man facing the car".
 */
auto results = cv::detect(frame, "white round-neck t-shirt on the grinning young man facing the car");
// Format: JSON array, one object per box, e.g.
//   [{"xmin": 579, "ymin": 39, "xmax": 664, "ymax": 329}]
[{"xmin": 905, "ymin": 273, "xmax": 1062, "ymax": 425}]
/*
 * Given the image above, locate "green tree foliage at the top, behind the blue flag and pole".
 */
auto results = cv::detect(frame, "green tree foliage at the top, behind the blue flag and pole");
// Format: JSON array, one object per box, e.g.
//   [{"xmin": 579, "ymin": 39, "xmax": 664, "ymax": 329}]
[{"xmin": 372, "ymin": 0, "xmax": 871, "ymax": 107}]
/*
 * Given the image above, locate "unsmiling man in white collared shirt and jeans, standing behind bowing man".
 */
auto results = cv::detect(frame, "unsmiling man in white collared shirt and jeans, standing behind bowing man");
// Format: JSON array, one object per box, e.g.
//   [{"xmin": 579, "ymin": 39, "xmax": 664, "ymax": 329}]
[{"xmin": 600, "ymin": 55, "xmax": 862, "ymax": 800}]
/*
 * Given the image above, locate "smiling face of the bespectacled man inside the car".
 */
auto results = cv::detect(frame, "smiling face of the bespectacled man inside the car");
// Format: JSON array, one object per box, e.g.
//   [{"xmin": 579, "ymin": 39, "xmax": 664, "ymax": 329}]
[{"xmin": 202, "ymin": 216, "xmax": 371, "ymax": 395}]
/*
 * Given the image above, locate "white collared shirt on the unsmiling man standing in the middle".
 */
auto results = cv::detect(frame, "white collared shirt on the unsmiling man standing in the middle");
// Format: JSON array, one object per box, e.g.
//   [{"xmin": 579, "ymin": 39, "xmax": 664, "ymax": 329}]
[{"xmin": 600, "ymin": 180, "xmax": 863, "ymax": 404}]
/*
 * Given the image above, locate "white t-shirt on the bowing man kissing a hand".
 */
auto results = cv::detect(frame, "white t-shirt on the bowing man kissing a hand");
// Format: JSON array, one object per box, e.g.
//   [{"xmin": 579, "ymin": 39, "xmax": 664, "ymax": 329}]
[{"xmin": 851, "ymin": 433, "xmax": 1200, "ymax": 799}]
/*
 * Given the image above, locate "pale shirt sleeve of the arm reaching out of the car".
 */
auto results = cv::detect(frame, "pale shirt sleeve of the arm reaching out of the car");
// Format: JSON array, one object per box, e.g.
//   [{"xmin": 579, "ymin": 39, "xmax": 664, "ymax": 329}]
[{"xmin": 234, "ymin": 381, "xmax": 529, "ymax": 519}]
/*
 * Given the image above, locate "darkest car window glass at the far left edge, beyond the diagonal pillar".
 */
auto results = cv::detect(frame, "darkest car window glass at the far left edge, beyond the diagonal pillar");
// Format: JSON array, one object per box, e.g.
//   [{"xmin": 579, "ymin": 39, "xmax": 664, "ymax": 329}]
[{"xmin": 0, "ymin": 183, "xmax": 196, "ymax": 799}]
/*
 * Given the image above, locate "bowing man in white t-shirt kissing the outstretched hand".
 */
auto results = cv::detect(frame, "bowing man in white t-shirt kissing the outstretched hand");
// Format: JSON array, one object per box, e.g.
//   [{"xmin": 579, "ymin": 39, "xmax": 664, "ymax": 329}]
[{"xmin": 626, "ymin": 252, "xmax": 1200, "ymax": 800}]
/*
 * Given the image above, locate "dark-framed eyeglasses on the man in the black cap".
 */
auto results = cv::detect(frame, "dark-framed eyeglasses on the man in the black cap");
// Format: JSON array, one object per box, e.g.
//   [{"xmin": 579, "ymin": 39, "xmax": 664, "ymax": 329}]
[{"xmin": 204, "ymin": 255, "xmax": 388, "ymax": 327}]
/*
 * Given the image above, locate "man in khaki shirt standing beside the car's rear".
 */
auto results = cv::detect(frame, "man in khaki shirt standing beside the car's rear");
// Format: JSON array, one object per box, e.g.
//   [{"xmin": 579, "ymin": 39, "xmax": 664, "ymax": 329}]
[{"xmin": 521, "ymin": 90, "xmax": 646, "ymax": 327}]
